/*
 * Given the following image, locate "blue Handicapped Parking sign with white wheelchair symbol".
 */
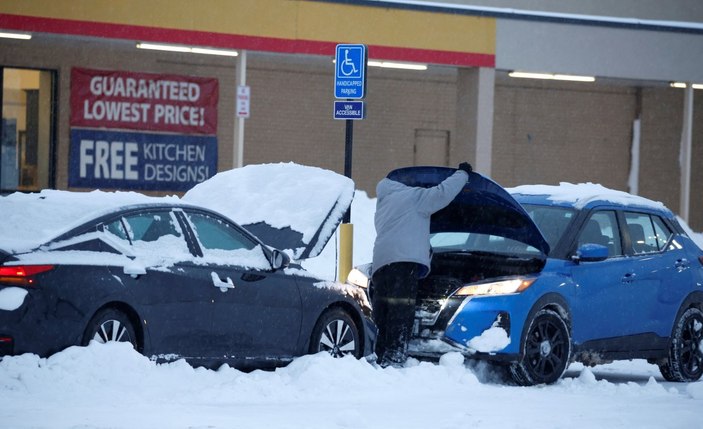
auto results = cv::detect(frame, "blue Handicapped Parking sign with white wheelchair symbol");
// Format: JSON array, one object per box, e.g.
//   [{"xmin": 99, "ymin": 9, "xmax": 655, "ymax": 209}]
[{"xmin": 334, "ymin": 45, "xmax": 367, "ymax": 99}]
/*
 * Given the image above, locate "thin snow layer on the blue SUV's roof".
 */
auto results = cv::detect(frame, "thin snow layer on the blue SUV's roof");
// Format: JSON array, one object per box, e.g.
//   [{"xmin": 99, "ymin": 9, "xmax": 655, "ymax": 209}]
[{"xmin": 506, "ymin": 182, "xmax": 669, "ymax": 211}]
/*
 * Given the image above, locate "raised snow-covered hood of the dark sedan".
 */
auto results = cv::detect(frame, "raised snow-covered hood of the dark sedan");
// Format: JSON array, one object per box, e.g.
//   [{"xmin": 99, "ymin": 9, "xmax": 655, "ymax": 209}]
[{"xmin": 183, "ymin": 163, "xmax": 354, "ymax": 260}]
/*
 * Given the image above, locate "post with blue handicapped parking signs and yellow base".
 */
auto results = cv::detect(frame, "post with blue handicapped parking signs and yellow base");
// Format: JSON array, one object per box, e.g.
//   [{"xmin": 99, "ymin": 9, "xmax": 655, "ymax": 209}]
[{"xmin": 333, "ymin": 44, "xmax": 368, "ymax": 282}]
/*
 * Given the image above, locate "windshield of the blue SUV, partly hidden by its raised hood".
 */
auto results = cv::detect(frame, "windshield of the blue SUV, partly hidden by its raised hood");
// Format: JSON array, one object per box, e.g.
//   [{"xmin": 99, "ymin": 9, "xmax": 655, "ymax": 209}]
[{"xmin": 430, "ymin": 205, "xmax": 576, "ymax": 257}]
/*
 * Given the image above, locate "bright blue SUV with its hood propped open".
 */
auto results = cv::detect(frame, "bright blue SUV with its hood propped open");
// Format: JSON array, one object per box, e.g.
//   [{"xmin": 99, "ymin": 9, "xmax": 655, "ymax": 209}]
[{"xmin": 350, "ymin": 167, "xmax": 703, "ymax": 385}]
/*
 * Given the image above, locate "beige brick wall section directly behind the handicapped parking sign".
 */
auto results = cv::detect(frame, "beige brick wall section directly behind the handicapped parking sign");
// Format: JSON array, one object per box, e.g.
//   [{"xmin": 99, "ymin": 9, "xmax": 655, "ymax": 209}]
[{"xmin": 244, "ymin": 56, "xmax": 456, "ymax": 194}]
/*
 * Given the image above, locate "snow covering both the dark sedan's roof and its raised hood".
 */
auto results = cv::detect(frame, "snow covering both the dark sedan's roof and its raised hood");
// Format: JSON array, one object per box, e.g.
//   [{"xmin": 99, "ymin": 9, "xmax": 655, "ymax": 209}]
[{"xmin": 0, "ymin": 163, "xmax": 354, "ymax": 260}]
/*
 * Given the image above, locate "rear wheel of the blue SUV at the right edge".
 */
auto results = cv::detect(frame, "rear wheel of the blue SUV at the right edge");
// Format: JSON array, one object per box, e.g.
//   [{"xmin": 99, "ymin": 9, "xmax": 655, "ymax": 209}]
[{"xmin": 659, "ymin": 307, "xmax": 703, "ymax": 382}]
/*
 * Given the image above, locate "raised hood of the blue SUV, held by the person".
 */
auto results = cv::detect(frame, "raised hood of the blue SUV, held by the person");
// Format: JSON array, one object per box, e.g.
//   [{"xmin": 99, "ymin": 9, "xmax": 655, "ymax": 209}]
[{"xmin": 388, "ymin": 167, "xmax": 549, "ymax": 255}]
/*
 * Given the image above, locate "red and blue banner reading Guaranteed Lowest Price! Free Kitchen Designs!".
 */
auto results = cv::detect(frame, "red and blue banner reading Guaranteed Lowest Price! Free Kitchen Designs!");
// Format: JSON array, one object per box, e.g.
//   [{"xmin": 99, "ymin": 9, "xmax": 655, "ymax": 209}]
[{"xmin": 69, "ymin": 68, "xmax": 219, "ymax": 191}]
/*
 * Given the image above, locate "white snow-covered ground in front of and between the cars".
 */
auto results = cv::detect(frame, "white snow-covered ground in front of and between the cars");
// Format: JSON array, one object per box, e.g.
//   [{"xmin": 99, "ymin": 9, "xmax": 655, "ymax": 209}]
[{"xmin": 0, "ymin": 166, "xmax": 703, "ymax": 429}]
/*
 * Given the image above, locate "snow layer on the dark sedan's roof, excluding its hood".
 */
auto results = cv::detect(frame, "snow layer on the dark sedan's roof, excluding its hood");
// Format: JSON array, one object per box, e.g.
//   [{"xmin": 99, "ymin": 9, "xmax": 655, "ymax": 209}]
[{"xmin": 0, "ymin": 189, "xmax": 180, "ymax": 252}]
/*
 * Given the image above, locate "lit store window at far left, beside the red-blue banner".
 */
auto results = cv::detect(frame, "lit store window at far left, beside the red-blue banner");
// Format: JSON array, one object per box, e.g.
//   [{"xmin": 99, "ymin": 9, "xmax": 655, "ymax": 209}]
[{"xmin": 0, "ymin": 67, "xmax": 55, "ymax": 193}]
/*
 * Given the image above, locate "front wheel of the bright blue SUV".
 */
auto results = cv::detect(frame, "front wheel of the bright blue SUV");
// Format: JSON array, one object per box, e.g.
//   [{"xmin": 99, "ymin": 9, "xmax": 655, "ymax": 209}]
[{"xmin": 510, "ymin": 309, "xmax": 571, "ymax": 386}]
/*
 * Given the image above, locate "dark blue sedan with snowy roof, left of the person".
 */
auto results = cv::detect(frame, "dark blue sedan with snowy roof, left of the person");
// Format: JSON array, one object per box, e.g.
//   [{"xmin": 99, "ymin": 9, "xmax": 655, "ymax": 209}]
[{"xmin": 0, "ymin": 169, "xmax": 375, "ymax": 368}]
